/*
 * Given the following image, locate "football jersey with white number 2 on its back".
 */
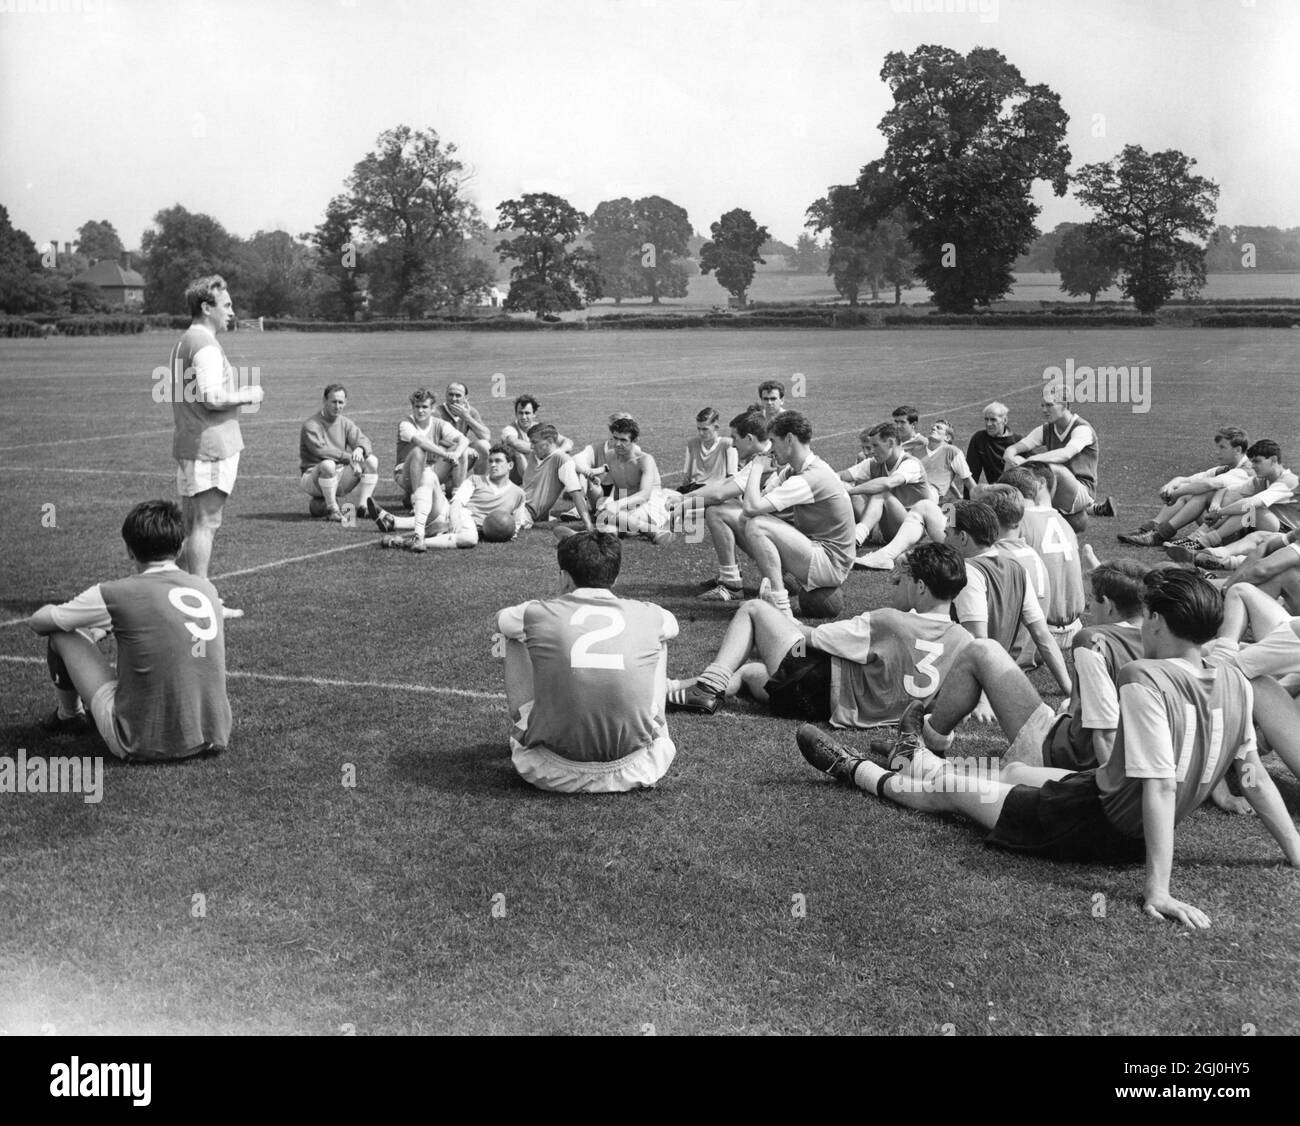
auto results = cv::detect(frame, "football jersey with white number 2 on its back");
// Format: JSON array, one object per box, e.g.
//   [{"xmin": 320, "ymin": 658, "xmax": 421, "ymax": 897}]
[{"xmin": 498, "ymin": 588, "xmax": 677, "ymax": 762}]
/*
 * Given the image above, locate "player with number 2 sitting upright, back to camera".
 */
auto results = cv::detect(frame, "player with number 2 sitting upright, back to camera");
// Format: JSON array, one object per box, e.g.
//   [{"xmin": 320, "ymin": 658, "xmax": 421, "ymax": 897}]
[{"xmin": 498, "ymin": 527, "xmax": 677, "ymax": 793}]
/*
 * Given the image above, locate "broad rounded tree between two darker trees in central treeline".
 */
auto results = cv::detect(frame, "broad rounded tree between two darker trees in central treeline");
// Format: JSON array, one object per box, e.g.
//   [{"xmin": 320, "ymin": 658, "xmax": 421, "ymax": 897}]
[{"xmin": 589, "ymin": 195, "xmax": 693, "ymax": 304}]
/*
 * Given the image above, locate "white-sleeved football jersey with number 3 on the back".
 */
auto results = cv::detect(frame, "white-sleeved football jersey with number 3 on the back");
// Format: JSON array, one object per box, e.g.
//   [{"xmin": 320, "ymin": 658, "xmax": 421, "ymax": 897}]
[{"xmin": 809, "ymin": 607, "xmax": 971, "ymax": 727}]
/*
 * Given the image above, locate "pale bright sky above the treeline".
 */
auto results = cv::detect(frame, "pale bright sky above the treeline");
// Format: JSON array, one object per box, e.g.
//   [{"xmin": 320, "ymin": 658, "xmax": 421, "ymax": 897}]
[{"xmin": 0, "ymin": 0, "xmax": 1300, "ymax": 247}]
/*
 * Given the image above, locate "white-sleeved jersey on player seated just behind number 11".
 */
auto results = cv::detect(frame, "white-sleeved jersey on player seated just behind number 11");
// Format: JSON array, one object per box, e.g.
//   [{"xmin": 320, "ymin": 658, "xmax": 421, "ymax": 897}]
[{"xmin": 1043, "ymin": 622, "xmax": 1141, "ymax": 770}]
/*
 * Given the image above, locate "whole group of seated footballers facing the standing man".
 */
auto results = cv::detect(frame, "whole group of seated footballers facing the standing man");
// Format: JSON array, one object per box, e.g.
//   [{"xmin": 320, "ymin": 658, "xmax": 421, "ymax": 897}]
[{"xmin": 31, "ymin": 382, "xmax": 1300, "ymax": 926}]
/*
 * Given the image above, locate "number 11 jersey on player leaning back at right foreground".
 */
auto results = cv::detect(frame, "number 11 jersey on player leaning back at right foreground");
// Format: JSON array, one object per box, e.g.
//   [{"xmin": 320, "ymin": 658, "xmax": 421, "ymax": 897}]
[{"xmin": 1097, "ymin": 659, "xmax": 1255, "ymax": 837}]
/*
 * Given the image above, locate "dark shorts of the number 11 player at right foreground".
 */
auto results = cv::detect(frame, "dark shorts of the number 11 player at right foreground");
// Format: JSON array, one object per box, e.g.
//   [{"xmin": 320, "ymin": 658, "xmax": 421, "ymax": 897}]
[{"xmin": 984, "ymin": 770, "xmax": 1147, "ymax": 863}]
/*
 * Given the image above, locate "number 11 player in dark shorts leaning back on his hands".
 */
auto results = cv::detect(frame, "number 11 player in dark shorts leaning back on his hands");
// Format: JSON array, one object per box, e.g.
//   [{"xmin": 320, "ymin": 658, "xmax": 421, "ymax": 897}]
[{"xmin": 797, "ymin": 568, "xmax": 1300, "ymax": 927}]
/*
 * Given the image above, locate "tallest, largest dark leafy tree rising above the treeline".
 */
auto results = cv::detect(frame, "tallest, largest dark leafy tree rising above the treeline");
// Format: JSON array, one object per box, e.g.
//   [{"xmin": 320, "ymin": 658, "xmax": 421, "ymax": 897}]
[{"xmin": 863, "ymin": 46, "xmax": 1070, "ymax": 312}]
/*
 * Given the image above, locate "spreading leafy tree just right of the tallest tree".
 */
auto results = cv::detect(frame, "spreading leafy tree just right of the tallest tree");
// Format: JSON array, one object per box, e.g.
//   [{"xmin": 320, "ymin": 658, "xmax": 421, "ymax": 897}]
[{"xmin": 1074, "ymin": 144, "xmax": 1218, "ymax": 313}]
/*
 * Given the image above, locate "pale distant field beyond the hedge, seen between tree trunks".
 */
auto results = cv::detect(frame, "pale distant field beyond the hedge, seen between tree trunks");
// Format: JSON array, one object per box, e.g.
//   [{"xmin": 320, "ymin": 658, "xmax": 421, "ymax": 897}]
[{"xmin": 585, "ymin": 267, "xmax": 1300, "ymax": 317}]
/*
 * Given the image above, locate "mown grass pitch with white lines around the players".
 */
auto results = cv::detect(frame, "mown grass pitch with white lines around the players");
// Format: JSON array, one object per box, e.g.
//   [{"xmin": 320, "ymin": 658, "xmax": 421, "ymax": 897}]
[{"xmin": 0, "ymin": 329, "xmax": 1300, "ymax": 1035}]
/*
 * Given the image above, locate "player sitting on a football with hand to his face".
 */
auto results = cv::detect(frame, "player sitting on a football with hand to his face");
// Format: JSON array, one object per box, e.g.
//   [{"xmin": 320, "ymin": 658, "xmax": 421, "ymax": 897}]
[{"xmin": 737, "ymin": 411, "xmax": 853, "ymax": 618}]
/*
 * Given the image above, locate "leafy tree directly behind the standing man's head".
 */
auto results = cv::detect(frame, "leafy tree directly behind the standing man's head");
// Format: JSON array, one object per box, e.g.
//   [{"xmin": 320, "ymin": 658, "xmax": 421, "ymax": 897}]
[{"xmin": 140, "ymin": 204, "xmax": 246, "ymax": 313}]
